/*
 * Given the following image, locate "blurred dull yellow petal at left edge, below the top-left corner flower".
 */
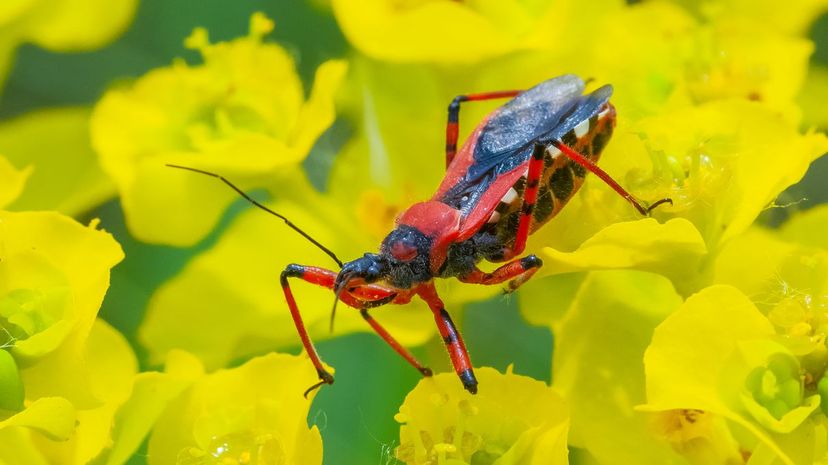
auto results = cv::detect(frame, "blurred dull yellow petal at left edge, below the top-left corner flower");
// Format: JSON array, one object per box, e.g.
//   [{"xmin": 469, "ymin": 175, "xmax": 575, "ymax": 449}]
[{"xmin": 0, "ymin": 107, "xmax": 115, "ymax": 216}]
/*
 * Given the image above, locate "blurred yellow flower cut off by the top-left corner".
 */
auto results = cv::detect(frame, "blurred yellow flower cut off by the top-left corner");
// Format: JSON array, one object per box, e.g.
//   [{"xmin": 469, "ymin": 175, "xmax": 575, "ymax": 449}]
[{"xmin": 0, "ymin": 0, "xmax": 137, "ymax": 86}]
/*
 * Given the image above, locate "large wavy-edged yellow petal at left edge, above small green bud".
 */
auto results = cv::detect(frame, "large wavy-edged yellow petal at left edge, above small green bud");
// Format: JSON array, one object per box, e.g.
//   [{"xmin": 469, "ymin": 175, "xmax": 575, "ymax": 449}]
[{"xmin": 0, "ymin": 212, "xmax": 123, "ymax": 408}]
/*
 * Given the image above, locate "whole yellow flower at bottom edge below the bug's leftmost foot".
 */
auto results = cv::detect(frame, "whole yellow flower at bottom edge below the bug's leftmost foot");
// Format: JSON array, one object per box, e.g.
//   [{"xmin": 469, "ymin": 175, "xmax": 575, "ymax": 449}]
[{"xmin": 98, "ymin": 351, "xmax": 322, "ymax": 465}]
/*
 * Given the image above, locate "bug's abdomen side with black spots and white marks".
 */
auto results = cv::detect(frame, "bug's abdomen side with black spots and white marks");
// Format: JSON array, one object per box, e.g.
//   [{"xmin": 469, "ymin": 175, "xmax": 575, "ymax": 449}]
[{"xmin": 484, "ymin": 103, "xmax": 615, "ymax": 252}]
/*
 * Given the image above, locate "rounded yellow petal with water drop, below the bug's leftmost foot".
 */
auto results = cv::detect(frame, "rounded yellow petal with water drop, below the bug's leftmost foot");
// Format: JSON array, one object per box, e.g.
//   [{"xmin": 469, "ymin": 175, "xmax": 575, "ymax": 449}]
[{"xmin": 149, "ymin": 354, "xmax": 322, "ymax": 465}]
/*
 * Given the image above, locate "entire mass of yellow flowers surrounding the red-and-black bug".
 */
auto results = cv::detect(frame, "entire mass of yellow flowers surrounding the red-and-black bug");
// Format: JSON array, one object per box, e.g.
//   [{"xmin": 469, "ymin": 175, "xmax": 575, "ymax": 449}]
[{"xmin": 0, "ymin": 0, "xmax": 828, "ymax": 465}]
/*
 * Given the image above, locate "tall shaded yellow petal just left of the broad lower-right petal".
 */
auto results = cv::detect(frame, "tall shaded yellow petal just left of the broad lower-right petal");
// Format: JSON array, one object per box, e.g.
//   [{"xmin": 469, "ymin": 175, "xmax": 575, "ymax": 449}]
[{"xmin": 548, "ymin": 271, "xmax": 681, "ymax": 464}]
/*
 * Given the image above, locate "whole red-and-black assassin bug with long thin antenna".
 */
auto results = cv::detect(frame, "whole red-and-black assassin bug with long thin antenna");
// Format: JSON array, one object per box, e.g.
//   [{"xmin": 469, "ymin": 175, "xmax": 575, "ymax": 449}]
[{"xmin": 170, "ymin": 75, "xmax": 672, "ymax": 396}]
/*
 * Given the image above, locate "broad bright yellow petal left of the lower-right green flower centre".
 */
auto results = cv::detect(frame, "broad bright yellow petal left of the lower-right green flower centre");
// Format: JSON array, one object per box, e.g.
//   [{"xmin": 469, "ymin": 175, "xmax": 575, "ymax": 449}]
[{"xmin": 639, "ymin": 285, "xmax": 810, "ymax": 465}]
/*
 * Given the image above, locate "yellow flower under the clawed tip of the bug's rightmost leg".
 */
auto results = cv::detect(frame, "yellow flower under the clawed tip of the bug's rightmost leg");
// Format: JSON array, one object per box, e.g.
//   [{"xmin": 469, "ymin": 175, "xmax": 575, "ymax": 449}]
[{"xmin": 536, "ymin": 100, "xmax": 828, "ymax": 295}]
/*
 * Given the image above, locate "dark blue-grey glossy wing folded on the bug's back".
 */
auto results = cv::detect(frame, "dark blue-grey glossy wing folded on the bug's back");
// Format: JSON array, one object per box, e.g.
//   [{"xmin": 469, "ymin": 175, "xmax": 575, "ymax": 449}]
[{"xmin": 441, "ymin": 74, "xmax": 612, "ymax": 217}]
